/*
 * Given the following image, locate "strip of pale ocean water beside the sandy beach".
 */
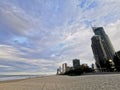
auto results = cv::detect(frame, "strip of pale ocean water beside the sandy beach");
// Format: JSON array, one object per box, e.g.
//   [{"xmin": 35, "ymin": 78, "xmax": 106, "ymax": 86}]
[{"xmin": 0, "ymin": 75, "xmax": 40, "ymax": 81}]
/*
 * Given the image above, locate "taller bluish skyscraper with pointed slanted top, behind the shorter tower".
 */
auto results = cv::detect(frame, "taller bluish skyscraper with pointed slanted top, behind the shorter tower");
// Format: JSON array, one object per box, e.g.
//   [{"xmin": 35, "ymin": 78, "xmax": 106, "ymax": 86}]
[{"xmin": 92, "ymin": 27, "xmax": 115, "ymax": 60}]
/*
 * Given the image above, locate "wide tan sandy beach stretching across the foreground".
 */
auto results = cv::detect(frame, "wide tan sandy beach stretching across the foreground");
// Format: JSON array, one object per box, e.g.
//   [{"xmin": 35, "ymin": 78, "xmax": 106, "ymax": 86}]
[{"xmin": 0, "ymin": 74, "xmax": 120, "ymax": 90}]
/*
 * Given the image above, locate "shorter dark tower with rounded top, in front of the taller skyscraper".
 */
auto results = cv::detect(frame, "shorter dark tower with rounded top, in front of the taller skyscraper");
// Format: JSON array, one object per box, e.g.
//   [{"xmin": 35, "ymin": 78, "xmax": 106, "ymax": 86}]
[{"xmin": 91, "ymin": 35, "xmax": 108, "ymax": 68}]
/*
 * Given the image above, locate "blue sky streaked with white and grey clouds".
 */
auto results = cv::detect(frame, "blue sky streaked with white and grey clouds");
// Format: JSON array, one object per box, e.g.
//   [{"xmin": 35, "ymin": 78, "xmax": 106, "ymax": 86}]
[{"xmin": 0, "ymin": 0, "xmax": 120, "ymax": 74}]
